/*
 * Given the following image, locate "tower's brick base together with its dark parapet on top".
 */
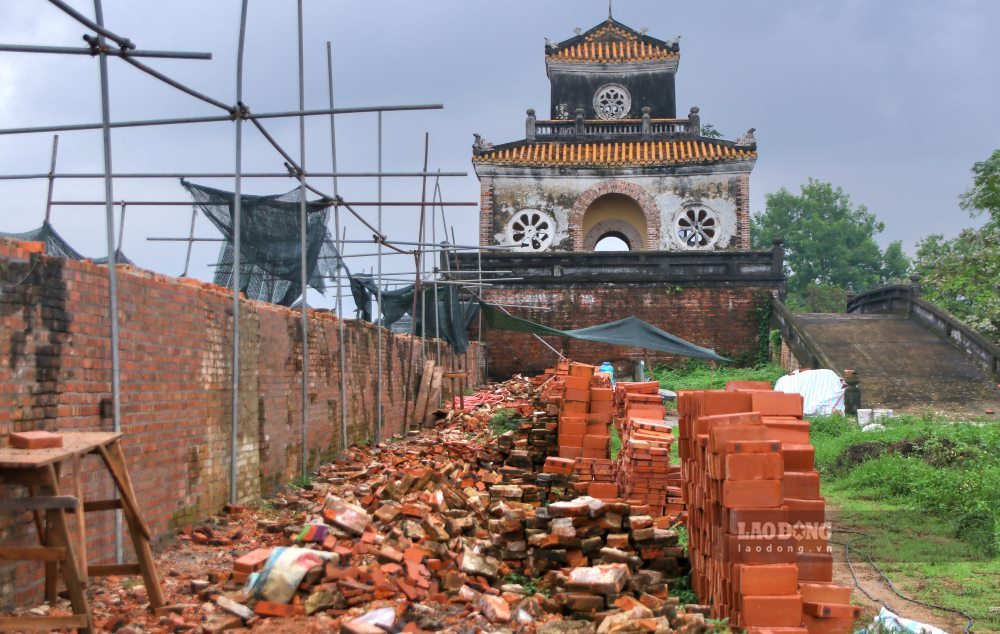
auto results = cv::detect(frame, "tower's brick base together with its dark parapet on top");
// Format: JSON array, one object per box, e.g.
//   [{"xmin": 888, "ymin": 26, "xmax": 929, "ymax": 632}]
[{"xmin": 460, "ymin": 247, "xmax": 784, "ymax": 378}]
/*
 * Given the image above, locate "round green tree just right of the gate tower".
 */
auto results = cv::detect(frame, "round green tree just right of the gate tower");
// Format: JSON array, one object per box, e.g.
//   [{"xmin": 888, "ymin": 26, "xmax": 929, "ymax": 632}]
[{"xmin": 751, "ymin": 179, "xmax": 909, "ymax": 312}]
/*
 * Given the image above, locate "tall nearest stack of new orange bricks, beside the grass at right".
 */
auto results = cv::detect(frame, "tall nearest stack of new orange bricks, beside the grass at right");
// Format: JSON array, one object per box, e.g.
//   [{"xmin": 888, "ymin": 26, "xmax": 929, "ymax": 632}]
[{"xmin": 678, "ymin": 386, "xmax": 858, "ymax": 633}]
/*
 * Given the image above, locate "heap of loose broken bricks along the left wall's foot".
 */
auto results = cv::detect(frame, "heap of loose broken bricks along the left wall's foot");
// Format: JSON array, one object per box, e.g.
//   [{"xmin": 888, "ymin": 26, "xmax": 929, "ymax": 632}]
[{"xmin": 145, "ymin": 362, "xmax": 732, "ymax": 633}]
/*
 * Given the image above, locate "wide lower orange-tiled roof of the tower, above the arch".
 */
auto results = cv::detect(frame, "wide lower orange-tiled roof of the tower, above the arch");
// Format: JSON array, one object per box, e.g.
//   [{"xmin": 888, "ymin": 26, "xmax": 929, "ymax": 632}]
[{"xmin": 472, "ymin": 137, "xmax": 757, "ymax": 167}]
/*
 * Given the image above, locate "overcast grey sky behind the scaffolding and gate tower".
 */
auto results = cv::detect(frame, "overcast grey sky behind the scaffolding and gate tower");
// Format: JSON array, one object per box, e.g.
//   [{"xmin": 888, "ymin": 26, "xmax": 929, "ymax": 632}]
[{"xmin": 0, "ymin": 0, "xmax": 1000, "ymax": 305}]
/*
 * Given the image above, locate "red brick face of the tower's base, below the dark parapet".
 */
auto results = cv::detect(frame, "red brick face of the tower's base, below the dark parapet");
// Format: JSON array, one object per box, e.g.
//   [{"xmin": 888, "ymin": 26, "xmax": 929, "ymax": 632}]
[{"xmin": 484, "ymin": 284, "xmax": 768, "ymax": 378}]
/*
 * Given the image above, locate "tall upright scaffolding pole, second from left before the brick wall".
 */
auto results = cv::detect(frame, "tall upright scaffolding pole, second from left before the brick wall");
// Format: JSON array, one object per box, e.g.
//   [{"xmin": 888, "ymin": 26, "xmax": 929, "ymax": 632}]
[{"xmin": 229, "ymin": 0, "xmax": 248, "ymax": 505}]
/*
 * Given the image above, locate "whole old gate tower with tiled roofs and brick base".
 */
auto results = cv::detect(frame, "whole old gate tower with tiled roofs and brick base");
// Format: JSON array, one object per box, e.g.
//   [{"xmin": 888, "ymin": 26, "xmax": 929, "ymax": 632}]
[{"xmin": 460, "ymin": 15, "xmax": 783, "ymax": 376}]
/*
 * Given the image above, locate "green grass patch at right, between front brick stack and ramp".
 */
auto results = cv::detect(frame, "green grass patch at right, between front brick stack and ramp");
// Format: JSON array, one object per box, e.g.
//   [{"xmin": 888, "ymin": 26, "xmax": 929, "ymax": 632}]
[{"xmin": 810, "ymin": 415, "xmax": 1000, "ymax": 632}]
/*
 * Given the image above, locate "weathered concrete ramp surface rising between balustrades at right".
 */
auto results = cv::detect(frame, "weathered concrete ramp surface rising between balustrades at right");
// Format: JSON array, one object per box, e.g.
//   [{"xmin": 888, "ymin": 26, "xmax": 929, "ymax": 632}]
[{"xmin": 795, "ymin": 313, "xmax": 1000, "ymax": 415}]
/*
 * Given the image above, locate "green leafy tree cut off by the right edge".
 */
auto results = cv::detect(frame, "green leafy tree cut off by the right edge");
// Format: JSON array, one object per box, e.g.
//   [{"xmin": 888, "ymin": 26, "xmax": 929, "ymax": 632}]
[{"xmin": 915, "ymin": 150, "xmax": 1000, "ymax": 343}]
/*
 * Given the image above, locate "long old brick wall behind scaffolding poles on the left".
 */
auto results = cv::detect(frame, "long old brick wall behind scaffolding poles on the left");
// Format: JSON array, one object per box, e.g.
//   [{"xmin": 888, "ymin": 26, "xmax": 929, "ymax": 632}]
[{"xmin": 0, "ymin": 240, "xmax": 477, "ymax": 605}]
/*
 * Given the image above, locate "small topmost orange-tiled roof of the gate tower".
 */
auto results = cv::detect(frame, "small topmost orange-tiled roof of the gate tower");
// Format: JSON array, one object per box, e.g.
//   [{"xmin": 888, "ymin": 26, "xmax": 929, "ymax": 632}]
[{"xmin": 545, "ymin": 18, "xmax": 680, "ymax": 64}]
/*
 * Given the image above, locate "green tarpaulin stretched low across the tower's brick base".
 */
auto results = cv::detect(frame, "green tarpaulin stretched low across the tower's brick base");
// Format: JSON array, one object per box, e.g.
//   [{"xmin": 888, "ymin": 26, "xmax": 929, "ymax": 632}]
[{"xmin": 479, "ymin": 302, "xmax": 729, "ymax": 363}]
